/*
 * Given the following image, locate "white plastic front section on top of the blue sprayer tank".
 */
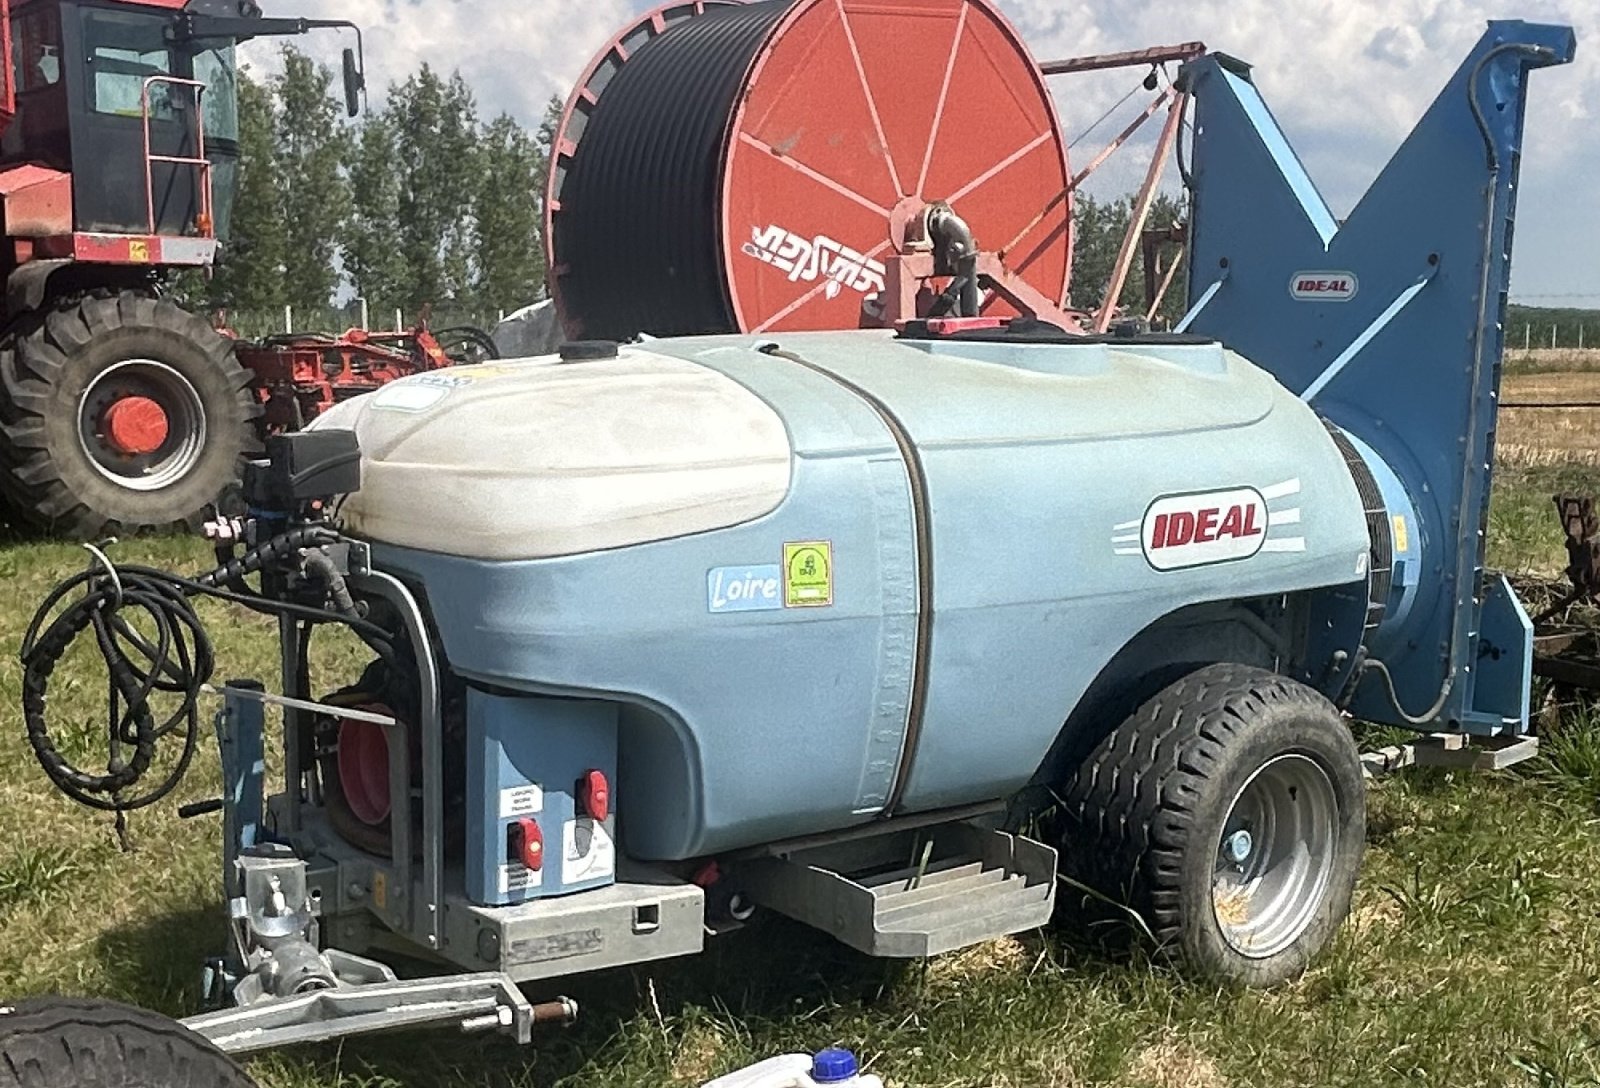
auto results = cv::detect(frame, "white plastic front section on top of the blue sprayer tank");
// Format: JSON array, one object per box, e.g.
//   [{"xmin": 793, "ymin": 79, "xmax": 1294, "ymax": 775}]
[{"xmin": 314, "ymin": 347, "xmax": 792, "ymax": 560}]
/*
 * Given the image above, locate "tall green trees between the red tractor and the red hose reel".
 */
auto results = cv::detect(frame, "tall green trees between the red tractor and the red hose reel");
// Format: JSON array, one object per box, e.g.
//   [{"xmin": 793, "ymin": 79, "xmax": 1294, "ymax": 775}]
[{"xmin": 198, "ymin": 46, "xmax": 560, "ymax": 324}]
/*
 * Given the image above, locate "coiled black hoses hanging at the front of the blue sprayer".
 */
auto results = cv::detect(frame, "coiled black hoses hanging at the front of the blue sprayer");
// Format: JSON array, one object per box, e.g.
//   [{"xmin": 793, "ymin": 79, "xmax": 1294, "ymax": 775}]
[{"xmin": 21, "ymin": 526, "xmax": 392, "ymax": 813}]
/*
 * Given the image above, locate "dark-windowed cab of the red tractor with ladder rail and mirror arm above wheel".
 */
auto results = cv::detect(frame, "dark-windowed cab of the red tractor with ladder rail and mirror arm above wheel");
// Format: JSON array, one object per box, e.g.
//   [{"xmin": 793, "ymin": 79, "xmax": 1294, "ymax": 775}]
[{"xmin": 0, "ymin": 0, "xmax": 360, "ymax": 252}]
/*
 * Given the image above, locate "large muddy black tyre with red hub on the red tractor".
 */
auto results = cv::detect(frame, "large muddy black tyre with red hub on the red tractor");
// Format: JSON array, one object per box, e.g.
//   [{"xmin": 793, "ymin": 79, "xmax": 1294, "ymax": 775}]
[{"xmin": 0, "ymin": 293, "xmax": 261, "ymax": 538}]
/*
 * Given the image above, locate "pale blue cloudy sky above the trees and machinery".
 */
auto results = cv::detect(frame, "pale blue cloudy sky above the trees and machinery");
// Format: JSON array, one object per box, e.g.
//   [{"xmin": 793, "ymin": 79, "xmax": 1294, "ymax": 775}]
[{"xmin": 246, "ymin": 0, "xmax": 1600, "ymax": 309}]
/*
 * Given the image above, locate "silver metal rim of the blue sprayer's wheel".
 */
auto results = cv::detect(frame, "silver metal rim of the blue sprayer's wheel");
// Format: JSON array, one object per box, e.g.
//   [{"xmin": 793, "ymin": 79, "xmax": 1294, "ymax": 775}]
[{"xmin": 1211, "ymin": 755, "xmax": 1339, "ymax": 960}]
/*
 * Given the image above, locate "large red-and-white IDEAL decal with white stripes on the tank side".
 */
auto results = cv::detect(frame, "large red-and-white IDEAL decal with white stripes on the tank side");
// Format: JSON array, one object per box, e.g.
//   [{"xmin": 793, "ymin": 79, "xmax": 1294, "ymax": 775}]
[{"xmin": 1112, "ymin": 480, "xmax": 1306, "ymax": 571}]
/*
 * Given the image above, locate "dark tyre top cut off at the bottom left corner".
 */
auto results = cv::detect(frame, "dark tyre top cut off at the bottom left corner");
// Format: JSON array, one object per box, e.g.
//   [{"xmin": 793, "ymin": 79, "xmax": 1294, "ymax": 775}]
[{"xmin": 0, "ymin": 998, "xmax": 256, "ymax": 1088}]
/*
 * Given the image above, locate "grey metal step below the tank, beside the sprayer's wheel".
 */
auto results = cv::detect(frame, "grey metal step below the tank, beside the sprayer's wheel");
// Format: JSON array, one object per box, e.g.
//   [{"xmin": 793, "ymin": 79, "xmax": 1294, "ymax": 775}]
[{"xmin": 739, "ymin": 822, "xmax": 1056, "ymax": 957}]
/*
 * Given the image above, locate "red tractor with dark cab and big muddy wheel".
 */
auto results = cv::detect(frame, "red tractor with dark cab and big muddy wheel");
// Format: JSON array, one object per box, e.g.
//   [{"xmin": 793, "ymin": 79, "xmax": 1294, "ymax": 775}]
[{"xmin": 0, "ymin": 0, "xmax": 363, "ymax": 536}]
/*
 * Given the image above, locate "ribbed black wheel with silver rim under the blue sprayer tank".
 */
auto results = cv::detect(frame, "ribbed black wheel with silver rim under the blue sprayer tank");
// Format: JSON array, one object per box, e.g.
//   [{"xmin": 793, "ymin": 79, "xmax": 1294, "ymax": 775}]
[{"xmin": 1061, "ymin": 664, "xmax": 1366, "ymax": 987}]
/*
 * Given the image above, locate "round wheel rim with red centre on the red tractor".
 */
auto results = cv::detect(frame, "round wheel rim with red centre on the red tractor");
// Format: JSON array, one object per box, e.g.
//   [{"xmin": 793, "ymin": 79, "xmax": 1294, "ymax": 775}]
[{"xmin": 78, "ymin": 358, "xmax": 206, "ymax": 491}]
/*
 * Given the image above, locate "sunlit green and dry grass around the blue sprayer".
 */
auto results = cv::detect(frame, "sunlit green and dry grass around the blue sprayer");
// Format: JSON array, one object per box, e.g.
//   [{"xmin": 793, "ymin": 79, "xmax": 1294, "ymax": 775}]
[{"xmin": 0, "ymin": 358, "xmax": 1600, "ymax": 1088}]
